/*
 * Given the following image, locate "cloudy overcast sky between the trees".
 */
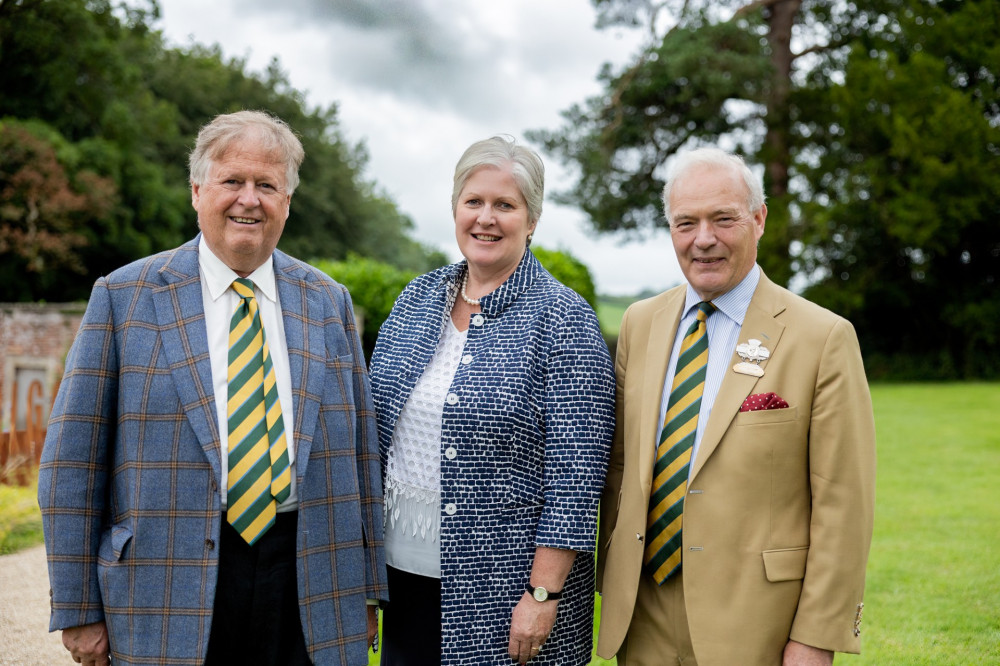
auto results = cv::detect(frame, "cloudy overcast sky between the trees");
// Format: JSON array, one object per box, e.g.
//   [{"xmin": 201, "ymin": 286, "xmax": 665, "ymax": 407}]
[{"xmin": 150, "ymin": 0, "xmax": 681, "ymax": 294}]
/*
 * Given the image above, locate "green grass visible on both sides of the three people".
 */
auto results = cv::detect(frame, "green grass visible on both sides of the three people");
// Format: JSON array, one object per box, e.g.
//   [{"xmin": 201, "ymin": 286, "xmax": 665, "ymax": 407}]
[{"xmin": 0, "ymin": 383, "xmax": 1000, "ymax": 666}]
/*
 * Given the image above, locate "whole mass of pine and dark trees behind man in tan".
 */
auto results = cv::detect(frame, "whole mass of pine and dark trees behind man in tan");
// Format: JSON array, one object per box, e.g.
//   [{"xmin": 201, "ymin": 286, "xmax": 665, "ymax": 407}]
[{"xmin": 529, "ymin": 0, "xmax": 1000, "ymax": 378}]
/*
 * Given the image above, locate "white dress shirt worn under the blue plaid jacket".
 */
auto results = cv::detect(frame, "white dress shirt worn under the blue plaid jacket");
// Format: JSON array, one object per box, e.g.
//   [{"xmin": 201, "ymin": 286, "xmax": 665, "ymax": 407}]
[{"xmin": 198, "ymin": 236, "xmax": 298, "ymax": 513}]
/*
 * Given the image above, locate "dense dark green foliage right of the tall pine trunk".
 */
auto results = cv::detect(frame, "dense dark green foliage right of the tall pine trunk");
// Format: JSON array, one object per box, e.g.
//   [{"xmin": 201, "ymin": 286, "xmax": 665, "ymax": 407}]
[{"xmin": 800, "ymin": 2, "xmax": 1000, "ymax": 379}]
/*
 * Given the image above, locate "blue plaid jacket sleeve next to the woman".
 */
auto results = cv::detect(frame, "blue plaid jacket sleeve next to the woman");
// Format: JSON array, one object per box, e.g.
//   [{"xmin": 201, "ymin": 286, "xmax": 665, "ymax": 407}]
[{"xmin": 343, "ymin": 289, "xmax": 389, "ymax": 601}]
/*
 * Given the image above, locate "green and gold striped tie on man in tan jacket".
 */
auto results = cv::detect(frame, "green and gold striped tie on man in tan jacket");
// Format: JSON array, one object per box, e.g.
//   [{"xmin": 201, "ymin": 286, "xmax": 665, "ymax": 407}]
[{"xmin": 643, "ymin": 302, "xmax": 715, "ymax": 585}]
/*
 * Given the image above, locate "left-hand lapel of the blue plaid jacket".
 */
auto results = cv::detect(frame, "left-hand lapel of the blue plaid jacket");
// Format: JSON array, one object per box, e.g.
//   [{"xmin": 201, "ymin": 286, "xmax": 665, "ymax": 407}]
[{"xmin": 152, "ymin": 235, "xmax": 222, "ymax": 479}]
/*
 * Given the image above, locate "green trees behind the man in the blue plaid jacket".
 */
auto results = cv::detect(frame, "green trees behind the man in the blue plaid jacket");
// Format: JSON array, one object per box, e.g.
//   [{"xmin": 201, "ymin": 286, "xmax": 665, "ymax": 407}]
[{"xmin": 0, "ymin": 0, "xmax": 440, "ymax": 301}]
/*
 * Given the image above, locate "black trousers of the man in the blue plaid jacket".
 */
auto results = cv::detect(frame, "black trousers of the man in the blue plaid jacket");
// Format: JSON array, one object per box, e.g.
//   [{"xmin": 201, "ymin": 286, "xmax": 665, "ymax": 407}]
[{"xmin": 205, "ymin": 511, "xmax": 312, "ymax": 666}]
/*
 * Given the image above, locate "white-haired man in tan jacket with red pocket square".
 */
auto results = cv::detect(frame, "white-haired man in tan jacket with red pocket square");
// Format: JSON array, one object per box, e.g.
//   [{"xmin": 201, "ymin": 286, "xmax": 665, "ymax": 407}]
[{"xmin": 597, "ymin": 148, "xmax": 875, "ymax": 666}]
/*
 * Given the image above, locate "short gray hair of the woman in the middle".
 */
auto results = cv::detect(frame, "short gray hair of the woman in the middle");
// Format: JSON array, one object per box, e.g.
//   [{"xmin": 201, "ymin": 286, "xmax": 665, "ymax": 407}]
[{"xmin": 451, "ymin": 136, "xmax": 545, "ymax": 223}]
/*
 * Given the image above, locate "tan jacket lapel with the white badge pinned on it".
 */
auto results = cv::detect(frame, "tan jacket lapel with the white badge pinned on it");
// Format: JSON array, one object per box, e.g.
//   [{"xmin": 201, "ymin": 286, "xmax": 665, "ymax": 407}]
[{"xmin": 691, "ymin": 273, "xmax": 785, "ymax": 480}]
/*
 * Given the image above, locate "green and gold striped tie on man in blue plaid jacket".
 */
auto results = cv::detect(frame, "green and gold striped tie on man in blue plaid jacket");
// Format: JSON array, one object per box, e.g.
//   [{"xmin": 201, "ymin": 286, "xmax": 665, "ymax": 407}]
[{"xmin": 226, "ymin": 278, "xmax": 291, "ymax": 544}]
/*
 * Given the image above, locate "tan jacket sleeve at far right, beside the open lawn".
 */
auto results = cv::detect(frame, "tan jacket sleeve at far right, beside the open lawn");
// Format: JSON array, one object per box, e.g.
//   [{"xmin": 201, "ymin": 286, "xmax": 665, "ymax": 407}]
[{"xmin": 791, "ymin": 320, "xmax": 875, "ymax": 652}]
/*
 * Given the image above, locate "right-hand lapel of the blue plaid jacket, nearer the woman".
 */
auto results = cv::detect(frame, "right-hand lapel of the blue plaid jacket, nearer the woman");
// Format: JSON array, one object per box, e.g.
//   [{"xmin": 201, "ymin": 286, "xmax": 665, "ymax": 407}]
[{"xmin": 274, "ymin": 251, "xmax": 324, "ymax": 484}]
